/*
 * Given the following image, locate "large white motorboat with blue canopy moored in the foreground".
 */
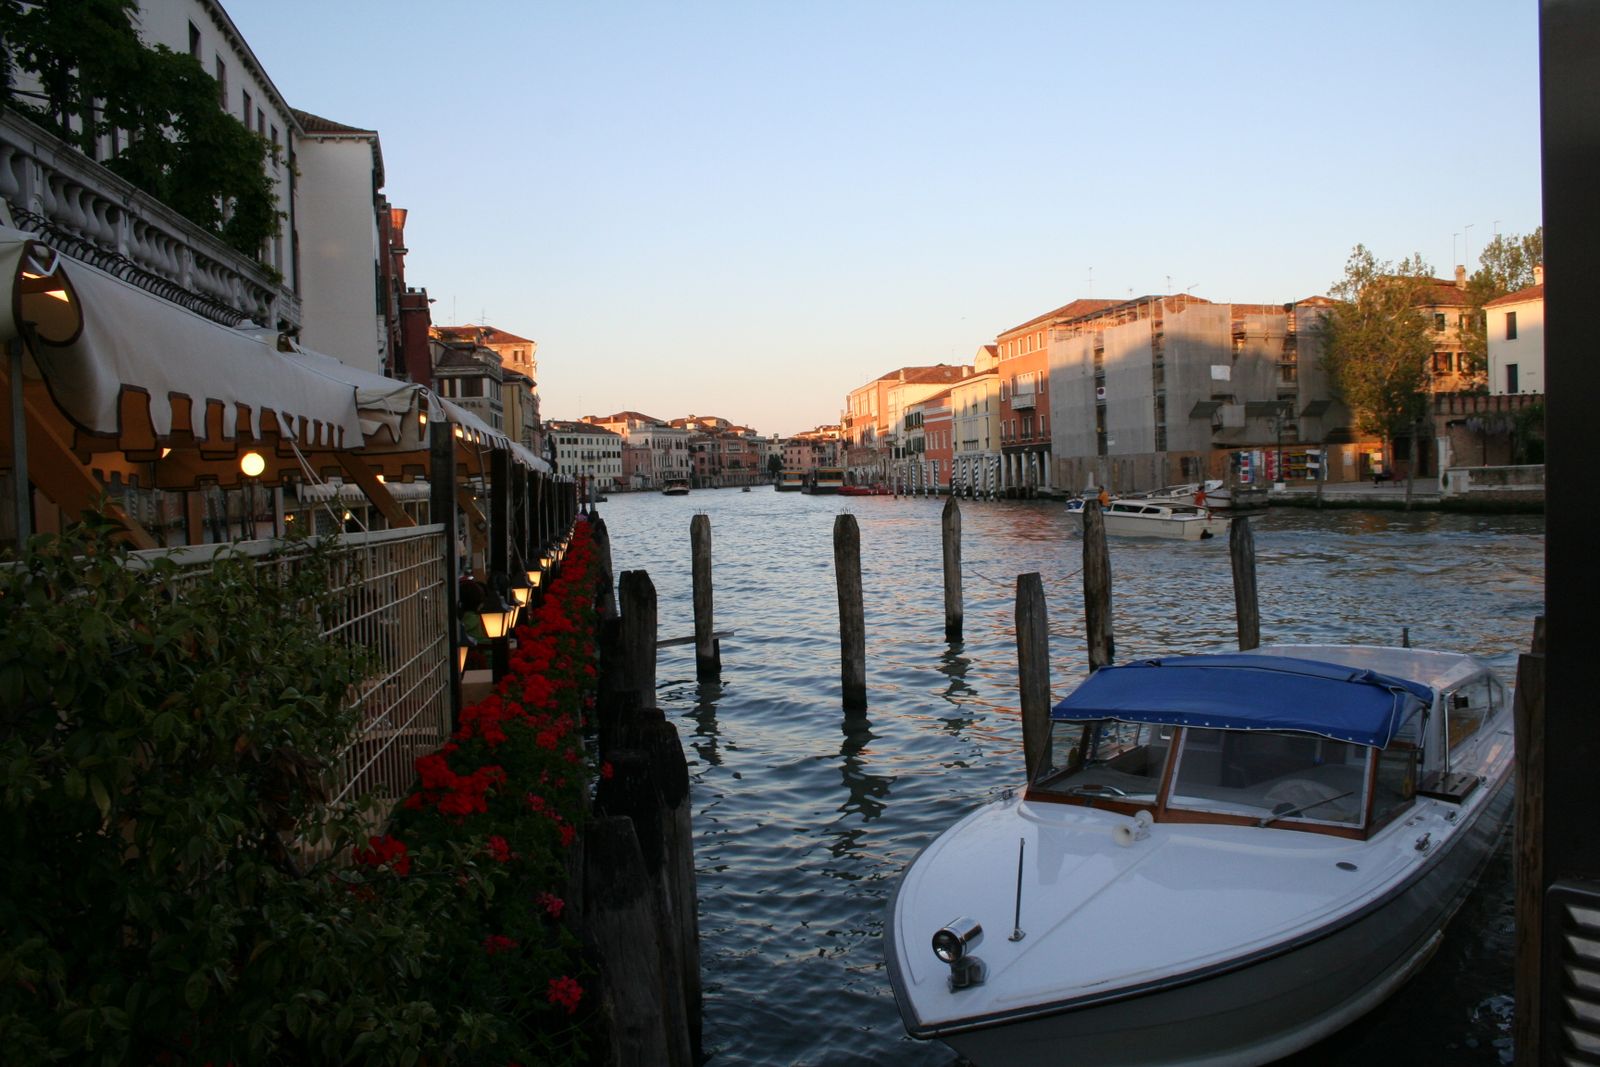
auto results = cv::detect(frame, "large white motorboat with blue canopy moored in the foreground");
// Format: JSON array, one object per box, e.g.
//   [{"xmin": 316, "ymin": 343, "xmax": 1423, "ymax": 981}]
[{"xmin": 886, "ymin": 645, "xmax": 1512, "ymax": 1067}]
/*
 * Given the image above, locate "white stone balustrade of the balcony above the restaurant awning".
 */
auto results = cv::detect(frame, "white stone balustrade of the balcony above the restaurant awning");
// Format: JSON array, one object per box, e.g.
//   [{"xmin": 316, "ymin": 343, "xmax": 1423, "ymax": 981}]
[{"xmin": 0, "ymin": 112, "xmax": 301, "ymax": 328}]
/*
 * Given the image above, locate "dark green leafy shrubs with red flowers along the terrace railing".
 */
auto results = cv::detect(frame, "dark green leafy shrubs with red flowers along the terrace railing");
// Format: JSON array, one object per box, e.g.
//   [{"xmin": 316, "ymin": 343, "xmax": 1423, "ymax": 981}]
[{"xmin": 0, "ymin": 511, "xmax": 598, "ymax": 1067}]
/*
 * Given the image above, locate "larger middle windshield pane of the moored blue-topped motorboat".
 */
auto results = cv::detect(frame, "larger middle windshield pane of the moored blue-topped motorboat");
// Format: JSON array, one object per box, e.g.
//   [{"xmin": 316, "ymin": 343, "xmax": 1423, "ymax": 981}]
[{"xmin": 1166, "ymin": 728, "xmax": 1371, "ymax": 825}]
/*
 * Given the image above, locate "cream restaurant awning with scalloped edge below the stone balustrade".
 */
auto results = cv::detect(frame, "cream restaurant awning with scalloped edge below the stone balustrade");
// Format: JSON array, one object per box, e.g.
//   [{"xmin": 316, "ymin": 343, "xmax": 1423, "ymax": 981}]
[{"xmin": 0, "ymin": 226, "xmax": 550, "ymax": 499}]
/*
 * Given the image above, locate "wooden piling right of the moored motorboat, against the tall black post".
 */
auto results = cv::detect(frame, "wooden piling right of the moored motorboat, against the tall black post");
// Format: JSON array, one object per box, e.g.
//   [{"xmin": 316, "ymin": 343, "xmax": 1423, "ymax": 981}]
[{"xmin": 1512, "ymin": 616, "xmax": 1544, "ymax": 1064}]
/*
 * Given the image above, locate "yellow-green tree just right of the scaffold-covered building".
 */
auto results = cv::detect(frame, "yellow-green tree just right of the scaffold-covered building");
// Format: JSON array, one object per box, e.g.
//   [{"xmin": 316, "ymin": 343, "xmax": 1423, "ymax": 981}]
[{"xmin": 1317, "ymin": 245, "xmax": 1434, "ymax": 446}]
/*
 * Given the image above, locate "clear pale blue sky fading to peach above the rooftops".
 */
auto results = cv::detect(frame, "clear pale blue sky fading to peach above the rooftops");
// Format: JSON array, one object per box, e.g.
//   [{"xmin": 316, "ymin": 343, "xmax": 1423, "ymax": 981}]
[{"xmin": 222, "ymin": 0, "xmax": 1541, "ymax": 435}]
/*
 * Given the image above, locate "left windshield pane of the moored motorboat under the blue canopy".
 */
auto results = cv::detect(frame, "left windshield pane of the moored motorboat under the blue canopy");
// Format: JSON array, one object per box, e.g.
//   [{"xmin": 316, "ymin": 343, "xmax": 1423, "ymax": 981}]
[{"xmin": 1034, "ymin": 718, "xmax": 1176, "ymax": 803}]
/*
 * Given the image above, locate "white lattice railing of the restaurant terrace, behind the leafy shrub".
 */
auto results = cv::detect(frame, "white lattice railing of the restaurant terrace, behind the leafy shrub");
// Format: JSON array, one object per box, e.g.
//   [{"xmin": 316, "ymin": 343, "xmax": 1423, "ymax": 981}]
[{"xmin": 133, "ymin": 525, "xmax": 454, "ymax": 808}]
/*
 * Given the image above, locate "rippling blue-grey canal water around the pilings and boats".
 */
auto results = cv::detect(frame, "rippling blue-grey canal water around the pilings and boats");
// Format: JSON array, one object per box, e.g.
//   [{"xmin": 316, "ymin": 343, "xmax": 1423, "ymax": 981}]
[{"xmin": 598, "ymin": 488, "xmax": 1544, "ymax": 1067}]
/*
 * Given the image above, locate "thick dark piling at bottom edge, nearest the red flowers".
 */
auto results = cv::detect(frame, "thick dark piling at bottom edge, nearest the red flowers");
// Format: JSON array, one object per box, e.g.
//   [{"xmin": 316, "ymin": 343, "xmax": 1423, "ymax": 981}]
[{"xmin": 584, "ymin": 816, "xmax": 688, "ymax": 1067}]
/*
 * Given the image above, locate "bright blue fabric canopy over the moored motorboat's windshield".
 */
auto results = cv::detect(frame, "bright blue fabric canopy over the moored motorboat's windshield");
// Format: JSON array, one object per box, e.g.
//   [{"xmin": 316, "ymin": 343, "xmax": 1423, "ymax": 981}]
[{"xmin": 1050, "ymin": 653, "xmax": 1434, "ymax": 749}]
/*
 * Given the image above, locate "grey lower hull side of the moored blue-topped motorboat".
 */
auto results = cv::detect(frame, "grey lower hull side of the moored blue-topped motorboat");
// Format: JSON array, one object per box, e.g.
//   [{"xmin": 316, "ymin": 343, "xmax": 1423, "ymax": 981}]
[{"xmin": 915, "ymin": 774, "xmax": 1512, "ymax": 1067}]
